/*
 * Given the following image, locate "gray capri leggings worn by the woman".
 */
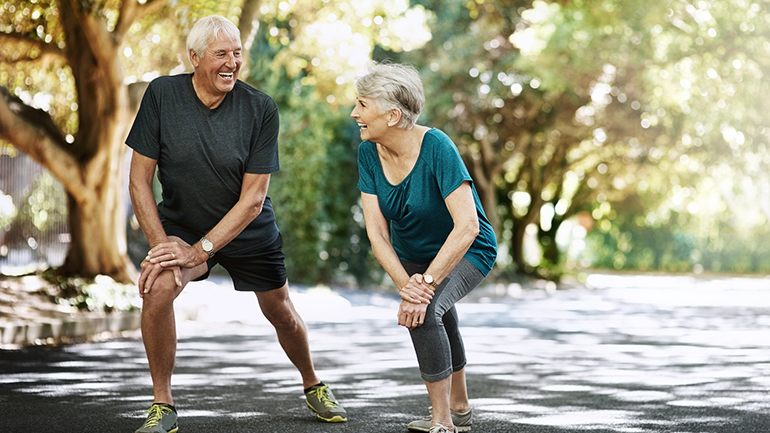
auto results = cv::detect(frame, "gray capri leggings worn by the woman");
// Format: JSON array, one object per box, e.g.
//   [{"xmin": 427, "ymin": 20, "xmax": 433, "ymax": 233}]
[{"xmin": 401, "ymin": 258, "xmax": 484, "ymax": 382}]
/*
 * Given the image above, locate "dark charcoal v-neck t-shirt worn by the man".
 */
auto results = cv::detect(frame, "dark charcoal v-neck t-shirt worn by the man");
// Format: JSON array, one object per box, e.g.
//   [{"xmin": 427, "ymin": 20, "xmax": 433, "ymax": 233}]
[{"xmin": 126, "ymin": 74, "xmax": 279, "ymax": 254}]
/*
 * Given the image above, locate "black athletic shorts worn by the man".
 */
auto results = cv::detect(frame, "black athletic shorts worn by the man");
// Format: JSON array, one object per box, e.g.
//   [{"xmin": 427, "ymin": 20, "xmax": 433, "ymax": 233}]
[{"xmin": 164, "ymin": 225, "xmax": 286, "ymax": 292}]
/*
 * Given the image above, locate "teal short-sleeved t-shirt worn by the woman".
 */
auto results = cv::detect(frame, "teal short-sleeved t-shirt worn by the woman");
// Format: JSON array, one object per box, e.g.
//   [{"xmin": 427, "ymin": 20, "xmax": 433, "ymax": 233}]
[{"xmin": 358, "ymin": 128, "xmax": 497, "ymax": 275}]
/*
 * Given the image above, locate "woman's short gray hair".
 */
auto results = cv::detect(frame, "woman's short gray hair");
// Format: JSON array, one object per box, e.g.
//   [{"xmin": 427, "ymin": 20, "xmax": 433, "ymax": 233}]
[{"xmin": 356, "ymin": 63, "xmax": 425, "ymax": 129}]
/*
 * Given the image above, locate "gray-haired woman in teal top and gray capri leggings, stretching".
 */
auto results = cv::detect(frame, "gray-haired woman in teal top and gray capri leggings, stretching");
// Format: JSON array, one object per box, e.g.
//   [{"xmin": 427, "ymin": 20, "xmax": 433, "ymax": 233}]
[{"xmin": 350, "ymin": 63, "xmax": 497, "ymax": 433}]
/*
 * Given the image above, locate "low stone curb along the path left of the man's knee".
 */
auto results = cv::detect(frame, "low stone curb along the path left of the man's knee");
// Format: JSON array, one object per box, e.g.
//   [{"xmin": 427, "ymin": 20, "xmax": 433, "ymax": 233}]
[{"xmin": 0, "ymin": 311, "xmax": 141, "ymax": 348}]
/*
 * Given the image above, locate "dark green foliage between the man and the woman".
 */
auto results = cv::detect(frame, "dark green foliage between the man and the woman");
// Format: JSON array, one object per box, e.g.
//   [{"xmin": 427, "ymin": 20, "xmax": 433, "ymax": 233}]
[{"xmin": 248, "ymin": 23, "xmax": 378, "ymax": 284}]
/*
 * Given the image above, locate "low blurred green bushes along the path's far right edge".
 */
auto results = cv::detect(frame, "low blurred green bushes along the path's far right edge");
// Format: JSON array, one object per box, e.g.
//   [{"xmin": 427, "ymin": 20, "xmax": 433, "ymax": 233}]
[{"xmin": 586, "ymin": 189, "xmax": 770, "ymax": 274}]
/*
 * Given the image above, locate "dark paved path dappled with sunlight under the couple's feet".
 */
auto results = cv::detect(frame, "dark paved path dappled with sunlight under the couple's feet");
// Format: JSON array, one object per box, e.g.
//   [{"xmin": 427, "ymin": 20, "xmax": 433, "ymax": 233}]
[{"xmin": 0, "ymin": 275, "xmax": 770, "ymax": 433}]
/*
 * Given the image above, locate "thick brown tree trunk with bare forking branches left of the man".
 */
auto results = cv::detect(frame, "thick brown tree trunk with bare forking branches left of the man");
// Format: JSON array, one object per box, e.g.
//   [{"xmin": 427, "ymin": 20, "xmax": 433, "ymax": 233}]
[{"xmin": 0, "ymin": 0, "xmax": 154, "ymax": 283}]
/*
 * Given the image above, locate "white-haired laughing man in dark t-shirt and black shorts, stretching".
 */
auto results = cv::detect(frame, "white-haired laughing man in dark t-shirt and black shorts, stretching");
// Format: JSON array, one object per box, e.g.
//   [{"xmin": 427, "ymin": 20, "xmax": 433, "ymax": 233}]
[{"xmin": 126, "ymin": 15, "xmax": 347, "ymax": 433}]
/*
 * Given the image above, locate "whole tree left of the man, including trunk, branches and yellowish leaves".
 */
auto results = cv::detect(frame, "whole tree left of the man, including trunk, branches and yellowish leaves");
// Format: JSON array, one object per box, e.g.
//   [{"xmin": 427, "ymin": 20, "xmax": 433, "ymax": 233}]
[{"xmin": 0, "ymin": 0, "xmax": 171, "ymax": 282}]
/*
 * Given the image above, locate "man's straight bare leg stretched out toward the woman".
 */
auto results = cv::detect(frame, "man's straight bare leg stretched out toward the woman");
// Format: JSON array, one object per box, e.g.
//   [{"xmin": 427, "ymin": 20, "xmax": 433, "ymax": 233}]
[{"xmin": 256, "ymin": 282, "xmax": 321, "ymax": 389}]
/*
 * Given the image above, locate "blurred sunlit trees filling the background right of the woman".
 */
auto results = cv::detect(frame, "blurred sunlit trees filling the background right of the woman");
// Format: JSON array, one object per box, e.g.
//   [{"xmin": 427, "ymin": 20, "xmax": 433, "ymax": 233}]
[{"xmin": 396, "ymin": 0, "xmax": 770, "ymax": 271}]
